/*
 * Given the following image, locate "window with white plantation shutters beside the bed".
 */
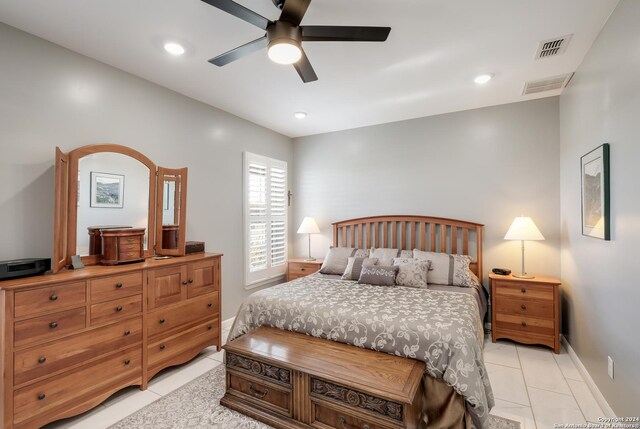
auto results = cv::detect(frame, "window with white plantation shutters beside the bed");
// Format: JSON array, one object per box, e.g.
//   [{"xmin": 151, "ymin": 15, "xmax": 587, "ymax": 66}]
[{"xmin": 244, "ymin": 152, "xmax": 288, "ymax": 287}]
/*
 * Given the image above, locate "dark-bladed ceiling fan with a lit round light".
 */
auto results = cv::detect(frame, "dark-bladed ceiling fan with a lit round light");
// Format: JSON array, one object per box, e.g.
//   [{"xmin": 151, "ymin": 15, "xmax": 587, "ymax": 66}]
[{"xmin": 202, "ymin": 0, "xmax": 391, "ymax": 83}]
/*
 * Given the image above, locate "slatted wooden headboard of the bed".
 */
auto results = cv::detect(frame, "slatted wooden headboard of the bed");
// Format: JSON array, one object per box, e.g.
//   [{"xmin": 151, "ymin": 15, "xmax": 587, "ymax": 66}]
[{"xmin": 332, "ymin": 215, "xmax": 484, "ymax": 281}]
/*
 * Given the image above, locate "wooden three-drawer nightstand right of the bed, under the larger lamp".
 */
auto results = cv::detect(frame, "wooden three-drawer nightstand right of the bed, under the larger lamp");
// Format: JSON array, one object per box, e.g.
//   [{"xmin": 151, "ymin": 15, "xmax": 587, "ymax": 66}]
[{"xmin": 489, "ymin": 274, "xmax": 560, "ymax": 353}]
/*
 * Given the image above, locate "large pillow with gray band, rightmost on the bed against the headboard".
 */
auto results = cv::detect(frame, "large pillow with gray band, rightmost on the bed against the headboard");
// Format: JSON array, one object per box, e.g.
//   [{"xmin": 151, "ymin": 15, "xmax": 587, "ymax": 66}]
[{"xmin": 413, "ymin": 249, "xmax": 473, "ymax": 287}]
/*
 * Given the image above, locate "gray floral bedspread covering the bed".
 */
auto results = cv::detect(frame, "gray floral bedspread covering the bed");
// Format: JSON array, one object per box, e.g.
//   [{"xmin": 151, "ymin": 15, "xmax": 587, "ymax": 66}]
[{"xmin": 229, "ymin": 276, "xmax": 494, "ymax": 428}]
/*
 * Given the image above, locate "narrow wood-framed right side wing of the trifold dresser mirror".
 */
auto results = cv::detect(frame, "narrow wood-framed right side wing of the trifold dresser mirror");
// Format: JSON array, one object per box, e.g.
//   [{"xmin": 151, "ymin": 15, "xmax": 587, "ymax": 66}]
[{"xmin": 156, "ymin": 167, "xmax": 187, "ymax": 255}]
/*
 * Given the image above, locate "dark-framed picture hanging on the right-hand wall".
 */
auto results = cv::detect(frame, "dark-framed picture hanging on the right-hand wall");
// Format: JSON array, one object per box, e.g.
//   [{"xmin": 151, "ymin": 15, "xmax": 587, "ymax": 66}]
[{"xmin": 580, "ymin": 143, "xmax": 610, "ymax": 240}]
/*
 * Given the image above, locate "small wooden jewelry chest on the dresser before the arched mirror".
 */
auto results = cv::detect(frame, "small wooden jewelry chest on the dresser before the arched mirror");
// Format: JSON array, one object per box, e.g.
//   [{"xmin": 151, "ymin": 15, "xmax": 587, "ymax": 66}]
[{"xmin": 100, "ymin": 228, "xmax": 146, "ymax": 265}]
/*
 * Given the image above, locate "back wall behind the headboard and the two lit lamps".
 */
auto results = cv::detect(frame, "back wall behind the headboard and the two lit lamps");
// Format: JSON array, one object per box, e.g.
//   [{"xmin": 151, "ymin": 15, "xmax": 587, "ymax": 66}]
[{"xmin": 292, "ymin": 97, "xmax": 560, "ymax": 285}]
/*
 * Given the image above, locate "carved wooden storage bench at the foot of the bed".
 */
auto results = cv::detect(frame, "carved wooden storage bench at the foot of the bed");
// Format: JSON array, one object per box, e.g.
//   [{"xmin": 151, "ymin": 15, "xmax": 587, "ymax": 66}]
[{"xmin": 220, "ymin": 327, "xmax": 425, "ymax": 429}]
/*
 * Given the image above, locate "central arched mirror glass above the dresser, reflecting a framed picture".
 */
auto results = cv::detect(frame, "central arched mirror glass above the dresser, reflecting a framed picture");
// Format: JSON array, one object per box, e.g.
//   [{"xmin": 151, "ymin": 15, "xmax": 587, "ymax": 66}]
[{"xmin": 74, "ymin": 152, "xmax": 155, "ymax": 256}]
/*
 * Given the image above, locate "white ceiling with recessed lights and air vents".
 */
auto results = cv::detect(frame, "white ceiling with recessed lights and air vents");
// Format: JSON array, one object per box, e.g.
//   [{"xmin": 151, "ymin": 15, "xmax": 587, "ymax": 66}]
[{"xmin": 0, "ymin": 0, "xmax": 618, "ymax": 137}]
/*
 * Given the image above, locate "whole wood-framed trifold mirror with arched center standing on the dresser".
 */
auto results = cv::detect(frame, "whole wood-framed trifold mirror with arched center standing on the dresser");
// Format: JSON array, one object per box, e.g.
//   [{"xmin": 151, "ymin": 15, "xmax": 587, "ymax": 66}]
[{"xmin": 53, "ymin": 144, "xmax": 187, "ymax": 272}]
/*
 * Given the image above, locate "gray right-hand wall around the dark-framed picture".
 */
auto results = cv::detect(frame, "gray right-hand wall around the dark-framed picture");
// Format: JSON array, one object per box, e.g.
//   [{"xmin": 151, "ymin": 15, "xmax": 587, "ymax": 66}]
[{"xmin": 560, "ymin": 0, "xmax": 640, "ymax": 416}]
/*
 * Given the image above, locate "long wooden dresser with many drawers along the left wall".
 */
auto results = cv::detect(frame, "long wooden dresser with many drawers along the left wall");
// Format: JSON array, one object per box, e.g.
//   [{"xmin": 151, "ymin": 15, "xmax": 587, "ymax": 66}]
[{"xmin": 0, "ymin": 253, "xmax": 222, "ymax": 429}]
